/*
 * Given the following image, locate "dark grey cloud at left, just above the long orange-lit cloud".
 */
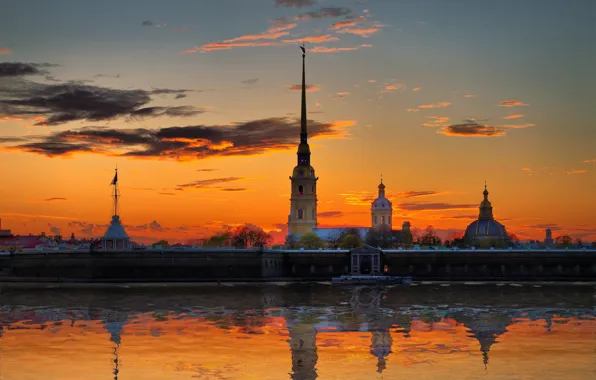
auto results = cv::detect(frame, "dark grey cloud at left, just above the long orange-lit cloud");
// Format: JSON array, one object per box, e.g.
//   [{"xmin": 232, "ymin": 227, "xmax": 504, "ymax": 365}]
[{"xmin": 0, "ymin": 80, "xmax": 204, "ymax": 125}]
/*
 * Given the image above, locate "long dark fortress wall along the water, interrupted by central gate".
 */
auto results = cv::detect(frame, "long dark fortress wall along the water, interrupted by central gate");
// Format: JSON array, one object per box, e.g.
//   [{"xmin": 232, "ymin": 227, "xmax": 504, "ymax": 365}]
[{"xmin": 0, "ymin": 249, "xmax": 596, "ymax": 281}]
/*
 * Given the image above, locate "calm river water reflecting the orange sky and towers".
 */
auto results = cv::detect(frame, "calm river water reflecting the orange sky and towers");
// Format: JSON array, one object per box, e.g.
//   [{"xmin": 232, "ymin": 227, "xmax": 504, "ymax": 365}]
[{"xmin": 0, "ymin": 284, "xmax": 596, "ymax": 380}]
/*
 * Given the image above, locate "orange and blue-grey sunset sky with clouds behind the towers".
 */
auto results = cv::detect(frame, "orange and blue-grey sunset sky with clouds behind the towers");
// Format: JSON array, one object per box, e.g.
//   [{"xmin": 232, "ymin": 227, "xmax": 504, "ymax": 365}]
[{"xmin": 0, "ymin": 0, "xmax": 596, "ymax": 243}]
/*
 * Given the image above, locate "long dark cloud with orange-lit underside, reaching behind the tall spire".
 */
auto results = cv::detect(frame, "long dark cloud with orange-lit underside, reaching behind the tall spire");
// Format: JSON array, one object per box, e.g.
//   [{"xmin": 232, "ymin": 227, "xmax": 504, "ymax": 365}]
[{"xmin": 0, "ymin": 118, "xmax": 354, "ymax": 160}]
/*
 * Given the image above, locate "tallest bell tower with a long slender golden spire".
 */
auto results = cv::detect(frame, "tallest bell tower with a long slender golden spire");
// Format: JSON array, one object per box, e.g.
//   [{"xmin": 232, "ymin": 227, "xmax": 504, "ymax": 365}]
[{"xmin": 288, "ymin": 45, "xmax": 319, "ymax": 235}]
